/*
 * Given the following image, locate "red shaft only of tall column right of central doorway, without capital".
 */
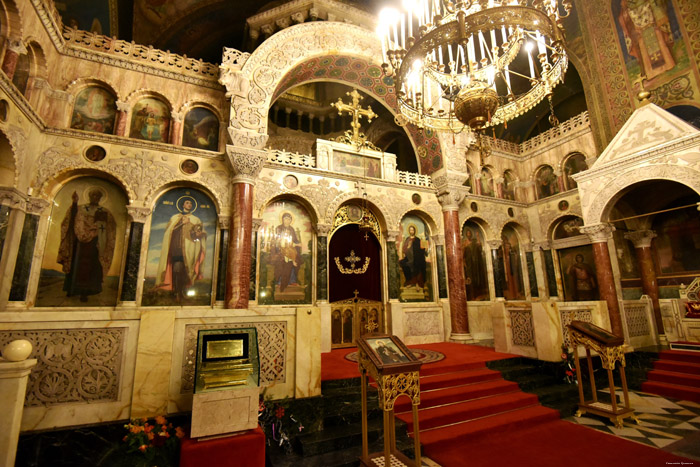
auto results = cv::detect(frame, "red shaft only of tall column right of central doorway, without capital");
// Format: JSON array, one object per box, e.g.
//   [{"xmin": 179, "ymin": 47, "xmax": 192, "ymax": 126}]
[{"xmin": 442, "ymin": 210, "xmax": 471, "ymax": 340}]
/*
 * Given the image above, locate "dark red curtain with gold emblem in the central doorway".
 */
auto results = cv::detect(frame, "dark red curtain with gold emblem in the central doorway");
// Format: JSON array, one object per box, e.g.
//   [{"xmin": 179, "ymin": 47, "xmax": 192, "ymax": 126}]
[{"xmin": 328, "ymin": 224, "xmax": 382, "ymax": 302}]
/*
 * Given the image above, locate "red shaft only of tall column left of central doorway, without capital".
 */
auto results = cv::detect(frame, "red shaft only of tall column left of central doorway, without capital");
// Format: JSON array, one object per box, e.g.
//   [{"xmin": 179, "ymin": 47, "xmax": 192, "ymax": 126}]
[{"xmin": 226, "ymin": 182, "xmax": 253, "ymax": 309}]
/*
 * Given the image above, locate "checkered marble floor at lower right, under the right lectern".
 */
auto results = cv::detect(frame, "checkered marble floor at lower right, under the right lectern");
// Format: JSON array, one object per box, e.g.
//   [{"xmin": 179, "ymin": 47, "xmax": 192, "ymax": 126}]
[{"xmin": 565, "ymin": 388, "xmax": 700, "ymax": 461}]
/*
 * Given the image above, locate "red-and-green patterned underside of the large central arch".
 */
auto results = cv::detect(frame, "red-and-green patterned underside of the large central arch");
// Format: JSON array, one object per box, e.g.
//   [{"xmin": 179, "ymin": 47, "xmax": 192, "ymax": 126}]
[{"xmin": 272, "ymin": 56, "xmax": 442, "ymax": 174}]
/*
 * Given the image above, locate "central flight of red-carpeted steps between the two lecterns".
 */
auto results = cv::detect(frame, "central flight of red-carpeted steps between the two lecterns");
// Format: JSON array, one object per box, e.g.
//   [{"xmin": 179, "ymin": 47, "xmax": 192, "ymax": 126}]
[{"xmin": 395, "ymin": 359, "xmax": 559, "ymax": 456}]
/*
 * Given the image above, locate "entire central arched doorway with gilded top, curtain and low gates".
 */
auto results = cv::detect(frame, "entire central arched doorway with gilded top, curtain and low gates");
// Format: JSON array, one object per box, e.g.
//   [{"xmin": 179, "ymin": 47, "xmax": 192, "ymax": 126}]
[{"xmin": 328, "ymin": 204, "xmax": 386, "ymax": 348}]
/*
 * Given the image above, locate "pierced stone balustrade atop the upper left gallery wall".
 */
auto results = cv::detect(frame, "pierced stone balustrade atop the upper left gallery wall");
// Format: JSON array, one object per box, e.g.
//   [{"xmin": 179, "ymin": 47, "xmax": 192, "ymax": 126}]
[{"xmin": 63, "ymin": 26, "xmax": 219, "ymax": 79}]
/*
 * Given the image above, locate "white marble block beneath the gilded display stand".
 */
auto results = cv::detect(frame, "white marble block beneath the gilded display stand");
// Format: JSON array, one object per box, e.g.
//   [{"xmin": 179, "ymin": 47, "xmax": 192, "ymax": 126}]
[{"xmin": 190, "ymin": 386, "xmax": 260, "ymax": 438}]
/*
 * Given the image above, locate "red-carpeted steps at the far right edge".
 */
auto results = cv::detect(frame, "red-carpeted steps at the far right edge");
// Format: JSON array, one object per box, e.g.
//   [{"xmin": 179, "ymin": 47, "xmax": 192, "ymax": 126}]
[{"xmin": 642, "ymin": 350, "xmax": 700, "ymax": 402}]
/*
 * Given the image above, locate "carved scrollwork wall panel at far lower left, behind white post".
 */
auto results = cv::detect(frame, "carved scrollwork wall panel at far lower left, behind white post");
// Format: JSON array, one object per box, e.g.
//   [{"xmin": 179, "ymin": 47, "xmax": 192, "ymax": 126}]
[{"xmin": 0, "ymin": 328, "xmax": 127, "ymax": 407}]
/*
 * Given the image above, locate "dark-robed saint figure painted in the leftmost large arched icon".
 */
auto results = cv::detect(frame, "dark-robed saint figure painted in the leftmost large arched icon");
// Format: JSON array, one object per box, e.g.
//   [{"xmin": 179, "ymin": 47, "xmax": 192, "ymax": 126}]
[{"xmin": 56, "ymin": 188, "xmax": 117, "ymax": 302}]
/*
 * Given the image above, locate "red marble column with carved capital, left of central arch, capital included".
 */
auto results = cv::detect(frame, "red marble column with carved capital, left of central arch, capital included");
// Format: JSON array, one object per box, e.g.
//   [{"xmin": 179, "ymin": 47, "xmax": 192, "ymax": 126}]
[{"xmin": 225, "ymin": 146, "xmax": 267, "ymax": 309}]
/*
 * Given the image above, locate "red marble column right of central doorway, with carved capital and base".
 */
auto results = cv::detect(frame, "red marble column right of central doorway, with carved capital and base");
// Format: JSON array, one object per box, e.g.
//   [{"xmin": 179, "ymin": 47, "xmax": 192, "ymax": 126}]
[{"xmin": 438, "ymin": 186, "xmax": 474, "ymax": 343}]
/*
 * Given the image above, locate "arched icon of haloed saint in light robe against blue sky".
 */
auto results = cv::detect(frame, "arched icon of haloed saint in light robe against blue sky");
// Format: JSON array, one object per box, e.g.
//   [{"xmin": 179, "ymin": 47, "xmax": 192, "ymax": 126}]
[{"xmin": 142, "ymin": 188, "xmax": 216, "ymax": 306}]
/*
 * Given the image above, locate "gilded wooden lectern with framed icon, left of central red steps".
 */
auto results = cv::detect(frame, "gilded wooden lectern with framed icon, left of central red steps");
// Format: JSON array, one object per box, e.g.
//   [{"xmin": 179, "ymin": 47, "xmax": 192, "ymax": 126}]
[{"xmin": 357, "ymin": 334, "xmax": 422, "ymax": 467}]
